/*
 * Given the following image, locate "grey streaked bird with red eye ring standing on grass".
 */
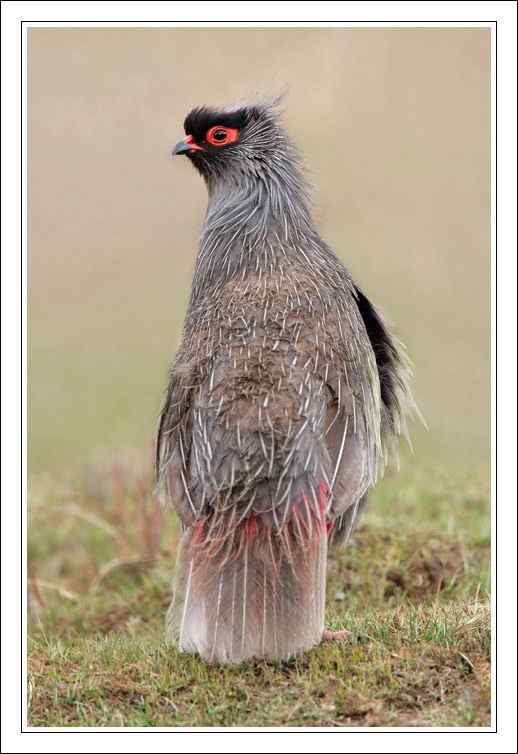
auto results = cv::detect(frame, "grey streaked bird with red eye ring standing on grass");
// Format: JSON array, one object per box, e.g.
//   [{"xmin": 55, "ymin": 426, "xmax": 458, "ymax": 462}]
[{"xmin": 156, "ymin": 99, "xmax": 417, "ymax": 664}]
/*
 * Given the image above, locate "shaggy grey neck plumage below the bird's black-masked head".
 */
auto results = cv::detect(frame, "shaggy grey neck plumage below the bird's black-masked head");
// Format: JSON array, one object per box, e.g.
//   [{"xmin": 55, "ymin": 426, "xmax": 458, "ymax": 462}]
[{"xmin": 191, "ymin": 154, "xmax": 314, "ymax": 305}]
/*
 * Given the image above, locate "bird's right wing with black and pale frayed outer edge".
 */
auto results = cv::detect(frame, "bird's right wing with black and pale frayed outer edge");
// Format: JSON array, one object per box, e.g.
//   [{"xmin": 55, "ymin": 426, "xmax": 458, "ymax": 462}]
[{"xmin": 326, "ymin": 287, "xmax": 417, "ymax": 540}]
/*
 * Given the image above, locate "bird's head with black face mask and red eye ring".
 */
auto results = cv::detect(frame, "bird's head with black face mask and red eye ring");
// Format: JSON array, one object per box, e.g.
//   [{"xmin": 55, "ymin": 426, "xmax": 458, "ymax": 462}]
[{"xmin": 173, "ymin": 102, "xmax": 296, "ymax": 186}]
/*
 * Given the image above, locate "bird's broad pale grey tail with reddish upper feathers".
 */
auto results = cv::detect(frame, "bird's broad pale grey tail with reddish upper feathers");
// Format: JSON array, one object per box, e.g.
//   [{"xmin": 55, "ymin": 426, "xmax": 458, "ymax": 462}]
[{"xmin": 167, "ymin": 494, "xmax": 327, "ymax": 663}]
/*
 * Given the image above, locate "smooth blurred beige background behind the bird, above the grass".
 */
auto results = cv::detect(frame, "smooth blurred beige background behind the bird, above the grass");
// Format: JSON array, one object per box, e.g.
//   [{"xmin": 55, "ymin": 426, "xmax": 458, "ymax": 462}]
[{"xmin": 28, "ymin": 29, "xmax": 490, "ymax": 472}]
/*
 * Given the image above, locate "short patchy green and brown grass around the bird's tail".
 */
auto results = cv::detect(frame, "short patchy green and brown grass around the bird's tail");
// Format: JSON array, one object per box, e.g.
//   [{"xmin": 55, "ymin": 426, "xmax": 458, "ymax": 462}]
[{"xmin": 28, "ymin": 457, "xmax": 490, "ymax": 727}]
